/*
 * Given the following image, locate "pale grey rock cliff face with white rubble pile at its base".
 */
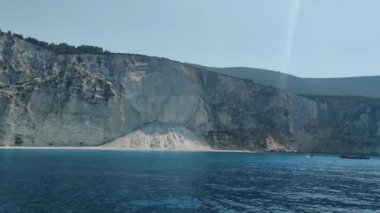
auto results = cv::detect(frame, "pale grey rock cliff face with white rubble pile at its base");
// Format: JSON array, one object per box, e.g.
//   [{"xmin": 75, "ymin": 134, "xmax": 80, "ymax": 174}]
[{"xmin": 0, "ymin": 34, "xmax": 380, "ymax": 153}]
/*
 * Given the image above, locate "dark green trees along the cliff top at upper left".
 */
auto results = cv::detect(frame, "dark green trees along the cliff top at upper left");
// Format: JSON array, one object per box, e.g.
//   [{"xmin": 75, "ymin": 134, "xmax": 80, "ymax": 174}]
[{"xmin": 0, "ymin": 30, "xmax": 111, "ymax": 54}]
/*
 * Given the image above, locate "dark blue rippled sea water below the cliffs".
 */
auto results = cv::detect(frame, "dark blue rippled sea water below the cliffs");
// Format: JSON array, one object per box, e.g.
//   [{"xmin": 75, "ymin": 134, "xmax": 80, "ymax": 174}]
[{"xmin": 0, "ymin": 150, "xmax": 380, "ymax": 212}]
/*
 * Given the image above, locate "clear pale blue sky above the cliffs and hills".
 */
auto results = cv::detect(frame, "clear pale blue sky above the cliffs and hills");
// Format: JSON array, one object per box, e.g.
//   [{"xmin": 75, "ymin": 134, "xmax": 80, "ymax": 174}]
[{"xmin": 0, "ymin": 0, "xmax": 380, "ymax": 77}]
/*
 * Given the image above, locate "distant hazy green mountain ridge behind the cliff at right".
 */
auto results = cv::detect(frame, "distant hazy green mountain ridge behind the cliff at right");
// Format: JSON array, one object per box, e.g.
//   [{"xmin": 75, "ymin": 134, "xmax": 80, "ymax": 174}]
[{"xmin": 189, "ymin": 64, "xmax": 380, "ymax": 98}]
